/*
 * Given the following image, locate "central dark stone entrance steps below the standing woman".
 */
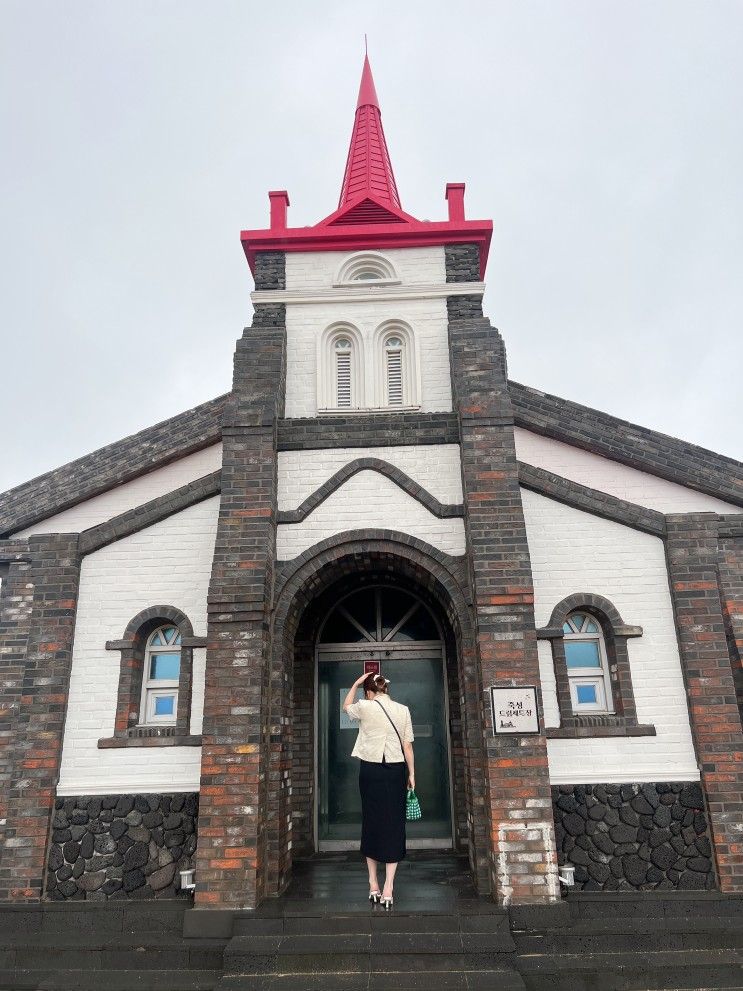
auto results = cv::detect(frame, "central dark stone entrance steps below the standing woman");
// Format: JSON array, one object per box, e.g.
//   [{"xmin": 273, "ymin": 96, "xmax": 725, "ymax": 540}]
[{"xmin": 217, "ymin": 905, "xmax": 526, "ymax": 991}]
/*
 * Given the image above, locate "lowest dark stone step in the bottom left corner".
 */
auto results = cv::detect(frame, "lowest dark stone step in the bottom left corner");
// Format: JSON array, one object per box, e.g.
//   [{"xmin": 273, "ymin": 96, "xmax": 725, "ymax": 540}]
[{"xmin": 0, "ymin": 960, "xmax": 219, "ymax": 991}]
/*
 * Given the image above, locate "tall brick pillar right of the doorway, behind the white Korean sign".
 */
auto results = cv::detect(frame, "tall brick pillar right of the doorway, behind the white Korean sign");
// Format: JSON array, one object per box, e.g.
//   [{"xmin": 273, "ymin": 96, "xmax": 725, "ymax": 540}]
[{"xmin": 449, "ymin": 280, "xmax": 559, "ymax": 904}]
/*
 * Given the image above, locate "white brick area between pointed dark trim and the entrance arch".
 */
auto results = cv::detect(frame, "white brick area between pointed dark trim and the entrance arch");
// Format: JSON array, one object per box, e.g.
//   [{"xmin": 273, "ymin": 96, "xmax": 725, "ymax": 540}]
[{"xmin": 277, "ymin": 471, "xmax": 465, "ymax": 561}]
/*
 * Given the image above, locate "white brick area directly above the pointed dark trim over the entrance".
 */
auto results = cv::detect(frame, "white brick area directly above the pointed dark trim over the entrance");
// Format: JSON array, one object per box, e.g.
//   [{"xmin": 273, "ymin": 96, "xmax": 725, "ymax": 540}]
[{"xmin": 279, "ymin": 444, "xmax": 462, "ymax": 509}]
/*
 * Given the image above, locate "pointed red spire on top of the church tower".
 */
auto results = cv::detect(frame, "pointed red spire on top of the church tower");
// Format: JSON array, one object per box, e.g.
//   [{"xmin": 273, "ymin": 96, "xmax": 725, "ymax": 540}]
[{"xmin": 338, "ymin": 57, "xmax": 402, "ymax": 213}]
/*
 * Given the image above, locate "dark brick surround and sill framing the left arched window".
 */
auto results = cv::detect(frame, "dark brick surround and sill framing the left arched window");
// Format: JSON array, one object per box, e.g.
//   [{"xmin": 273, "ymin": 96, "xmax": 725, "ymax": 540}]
[{"xmin": 107, "ymin": 605, "xmax": 196, "ymax": 747}]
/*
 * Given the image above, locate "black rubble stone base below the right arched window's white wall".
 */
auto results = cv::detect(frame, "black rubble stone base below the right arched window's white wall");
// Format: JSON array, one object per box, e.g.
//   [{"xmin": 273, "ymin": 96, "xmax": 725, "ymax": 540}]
[{"xmin": 552, "ymin": 782, "xmax": 715, "ymax": 891}]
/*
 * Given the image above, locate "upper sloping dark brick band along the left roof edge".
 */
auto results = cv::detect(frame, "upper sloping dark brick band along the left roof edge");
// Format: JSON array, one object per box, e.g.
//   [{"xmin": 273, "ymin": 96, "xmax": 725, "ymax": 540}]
[{"xmin": 0, "ymin": 396, "xmax": 228, "ymax": 536}]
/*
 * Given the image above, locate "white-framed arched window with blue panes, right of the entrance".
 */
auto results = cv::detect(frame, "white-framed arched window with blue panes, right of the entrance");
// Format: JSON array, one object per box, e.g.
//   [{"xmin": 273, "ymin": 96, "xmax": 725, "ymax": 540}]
[{"xmin": 562, "ymin": 611, "xmax": 614, "ymax": 713}]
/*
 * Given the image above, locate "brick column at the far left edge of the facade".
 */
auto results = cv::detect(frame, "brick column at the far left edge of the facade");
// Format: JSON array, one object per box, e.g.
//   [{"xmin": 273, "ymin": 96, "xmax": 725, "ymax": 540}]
[{"xmin": 0, "ymin": 534, "xmax": 80, "ymax": 902}]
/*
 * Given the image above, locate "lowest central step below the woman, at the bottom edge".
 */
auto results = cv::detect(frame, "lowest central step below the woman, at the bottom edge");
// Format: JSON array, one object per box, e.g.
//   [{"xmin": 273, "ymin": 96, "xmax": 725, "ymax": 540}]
[{"xmin": 216, "ymin": 968, "xmax": 527, "ymax": 991}]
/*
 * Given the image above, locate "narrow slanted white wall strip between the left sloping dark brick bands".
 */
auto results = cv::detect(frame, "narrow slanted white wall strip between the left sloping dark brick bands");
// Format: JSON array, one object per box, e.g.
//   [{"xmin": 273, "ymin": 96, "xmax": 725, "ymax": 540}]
[{"xmin": 15, "ymin": 444, "xmax": 222, "ymax": 537}]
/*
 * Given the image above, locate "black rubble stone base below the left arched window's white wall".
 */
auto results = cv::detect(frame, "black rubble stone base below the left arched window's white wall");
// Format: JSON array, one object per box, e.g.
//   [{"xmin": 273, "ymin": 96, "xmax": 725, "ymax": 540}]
[{"xmin": 46, "ymin": 793, "xmax": 199, "ymax": 901}]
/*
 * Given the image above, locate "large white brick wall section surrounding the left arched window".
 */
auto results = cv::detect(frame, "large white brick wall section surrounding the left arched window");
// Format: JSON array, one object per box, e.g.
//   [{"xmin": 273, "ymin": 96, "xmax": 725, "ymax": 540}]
[{"xmin": 58, "ymin": 497, "xmax": 219, "ymax": 795}]
